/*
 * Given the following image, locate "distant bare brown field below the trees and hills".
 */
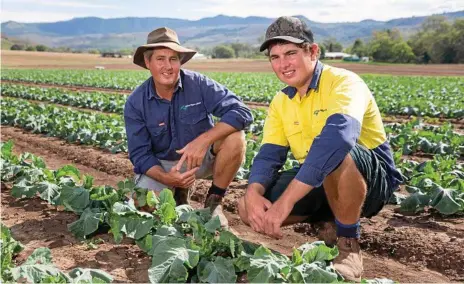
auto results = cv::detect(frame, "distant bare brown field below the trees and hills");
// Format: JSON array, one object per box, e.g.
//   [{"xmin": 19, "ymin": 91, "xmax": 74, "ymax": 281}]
[{"xmin": 2, "ymin": 50, "xmax": 464, "ymax": 76}]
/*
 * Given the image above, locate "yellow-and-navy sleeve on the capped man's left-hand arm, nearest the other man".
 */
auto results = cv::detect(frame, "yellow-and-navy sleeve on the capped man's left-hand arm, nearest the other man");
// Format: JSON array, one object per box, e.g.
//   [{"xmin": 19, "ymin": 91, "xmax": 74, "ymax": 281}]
[{"xmin": 248, "ymin": 98, "xmax": 289, "ymax": 189}]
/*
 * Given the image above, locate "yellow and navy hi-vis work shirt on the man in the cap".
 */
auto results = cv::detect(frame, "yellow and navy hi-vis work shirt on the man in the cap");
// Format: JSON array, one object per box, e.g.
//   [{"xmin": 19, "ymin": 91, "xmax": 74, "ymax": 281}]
[{"xmin": 249, "ymin": 62, "xmax": 401, "ymax": 190}]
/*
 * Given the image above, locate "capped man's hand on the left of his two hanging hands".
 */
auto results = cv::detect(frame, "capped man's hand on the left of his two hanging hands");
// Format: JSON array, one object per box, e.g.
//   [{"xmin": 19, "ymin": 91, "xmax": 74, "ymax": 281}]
[{"xmin": 245, "ymin": 185, "xmax": 272, "ymax": 233}]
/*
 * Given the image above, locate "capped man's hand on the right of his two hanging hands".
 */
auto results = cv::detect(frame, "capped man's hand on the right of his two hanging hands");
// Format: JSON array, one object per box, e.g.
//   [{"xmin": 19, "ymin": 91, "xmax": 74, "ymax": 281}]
[{"xmin": 263, "ymin": 199, "xmax": 294, "ymax": 239}]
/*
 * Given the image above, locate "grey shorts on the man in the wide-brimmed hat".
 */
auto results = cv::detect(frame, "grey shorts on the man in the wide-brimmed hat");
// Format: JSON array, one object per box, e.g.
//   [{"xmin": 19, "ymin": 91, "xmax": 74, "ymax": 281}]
[{"xmin": 134, "ymin": 146, "xmax": 216, "ymax": 191}]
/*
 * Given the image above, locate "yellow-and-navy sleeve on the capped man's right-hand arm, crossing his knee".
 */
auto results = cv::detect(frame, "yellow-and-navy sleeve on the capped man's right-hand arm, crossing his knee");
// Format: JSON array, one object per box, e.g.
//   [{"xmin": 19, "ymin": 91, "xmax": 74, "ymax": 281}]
[{"xmin": 295, "ymin": 77, "xmax": 372, "ymax": 187}]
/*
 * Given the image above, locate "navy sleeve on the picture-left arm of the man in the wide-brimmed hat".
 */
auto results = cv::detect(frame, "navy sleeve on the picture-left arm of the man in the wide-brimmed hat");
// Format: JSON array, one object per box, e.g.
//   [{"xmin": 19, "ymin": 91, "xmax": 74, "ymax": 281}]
[{"xmin": 124, "ymin": 97, "xmax": 161, "ymax": 174}]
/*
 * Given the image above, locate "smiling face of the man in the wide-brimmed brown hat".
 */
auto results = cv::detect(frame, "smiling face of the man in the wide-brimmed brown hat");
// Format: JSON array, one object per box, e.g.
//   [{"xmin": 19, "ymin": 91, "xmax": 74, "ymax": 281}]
[{"xmin": 145, "ymin": 48, "xmax": 180, "ymax": 88}]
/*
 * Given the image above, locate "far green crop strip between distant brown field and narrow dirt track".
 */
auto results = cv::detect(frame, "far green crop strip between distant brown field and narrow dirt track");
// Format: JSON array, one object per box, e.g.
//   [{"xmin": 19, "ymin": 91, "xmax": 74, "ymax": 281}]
[{"xmin": 1, "ymin": 69, "xmax": 464, "ymax": 118}]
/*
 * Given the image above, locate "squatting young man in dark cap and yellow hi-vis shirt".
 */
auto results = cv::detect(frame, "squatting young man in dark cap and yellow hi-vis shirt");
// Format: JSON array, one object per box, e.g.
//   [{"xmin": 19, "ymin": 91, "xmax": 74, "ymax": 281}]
[{"xmin": 239, "ymin": 17, "xmax": 401, "ymax": 281}]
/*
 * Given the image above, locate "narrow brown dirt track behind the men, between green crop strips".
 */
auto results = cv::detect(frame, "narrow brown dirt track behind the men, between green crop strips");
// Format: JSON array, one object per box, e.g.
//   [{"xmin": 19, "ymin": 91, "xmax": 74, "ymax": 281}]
[{"xmin": 2, "ymin": 80, "xmax": 464, "ymax": 128}]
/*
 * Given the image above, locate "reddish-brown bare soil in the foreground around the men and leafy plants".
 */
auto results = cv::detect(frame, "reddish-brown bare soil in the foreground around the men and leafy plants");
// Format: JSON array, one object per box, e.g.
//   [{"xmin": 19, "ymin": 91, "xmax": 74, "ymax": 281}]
[{"xmin": 1, "ymin": 127, "xmax": 464, "ymax": 282}]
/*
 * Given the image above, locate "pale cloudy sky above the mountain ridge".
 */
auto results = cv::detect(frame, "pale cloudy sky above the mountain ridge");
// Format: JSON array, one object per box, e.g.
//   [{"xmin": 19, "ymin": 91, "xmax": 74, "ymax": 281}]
[{"xmin": 0, "ymin": 0, "xmax": 464, "ymax": 23}]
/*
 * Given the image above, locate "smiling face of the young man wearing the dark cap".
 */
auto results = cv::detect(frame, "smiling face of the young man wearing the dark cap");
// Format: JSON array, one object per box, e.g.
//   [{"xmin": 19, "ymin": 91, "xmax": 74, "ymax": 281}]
[{"xmin": 269, "ymin": 43, "xmax": 317, "ymax": 88}]
